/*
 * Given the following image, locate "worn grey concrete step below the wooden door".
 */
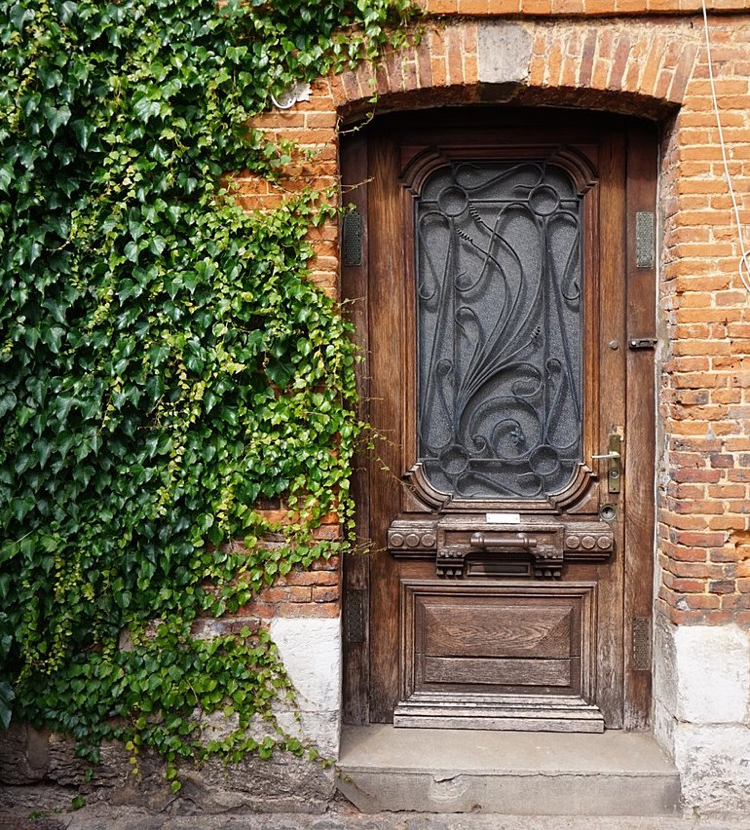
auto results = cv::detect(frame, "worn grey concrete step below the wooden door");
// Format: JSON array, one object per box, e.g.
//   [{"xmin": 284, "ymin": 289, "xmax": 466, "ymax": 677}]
[{"xmin": 338, "ymin": 724, "xmax": 680, "ymax": 816}]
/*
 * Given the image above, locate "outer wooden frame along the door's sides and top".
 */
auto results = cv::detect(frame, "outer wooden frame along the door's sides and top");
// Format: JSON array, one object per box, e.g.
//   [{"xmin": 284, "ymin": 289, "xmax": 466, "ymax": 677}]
[{"xmin": 341, "ymin": 108, "xmax": 657, "ymax": 730}]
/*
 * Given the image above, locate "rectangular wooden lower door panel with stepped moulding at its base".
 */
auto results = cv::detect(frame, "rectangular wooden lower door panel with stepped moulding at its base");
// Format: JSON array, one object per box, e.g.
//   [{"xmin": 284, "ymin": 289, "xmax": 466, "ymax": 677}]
[{"xmin": 396, "ymin": 579, "xmax": 602, "ymax": 731}]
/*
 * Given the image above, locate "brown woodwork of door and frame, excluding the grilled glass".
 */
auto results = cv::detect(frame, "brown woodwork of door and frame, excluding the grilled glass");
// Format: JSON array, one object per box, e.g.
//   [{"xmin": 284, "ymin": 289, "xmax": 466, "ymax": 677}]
[{"xmin": 342, "ymin": 108, "xmax": 656, "ymax": 731}]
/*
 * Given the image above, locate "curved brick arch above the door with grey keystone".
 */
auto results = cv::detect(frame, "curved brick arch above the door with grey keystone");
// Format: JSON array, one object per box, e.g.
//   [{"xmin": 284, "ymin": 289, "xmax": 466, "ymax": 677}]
[{"xmin": 330, "ymin": 20, "xmax": 699, "ymax": 118}]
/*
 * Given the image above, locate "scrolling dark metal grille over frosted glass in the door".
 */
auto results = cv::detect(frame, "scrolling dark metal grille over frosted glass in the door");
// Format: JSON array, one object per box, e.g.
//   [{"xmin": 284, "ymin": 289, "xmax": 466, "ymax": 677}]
[{"xmin": 415, "ymin": 162, "xmax": 582, "ymax": 499}]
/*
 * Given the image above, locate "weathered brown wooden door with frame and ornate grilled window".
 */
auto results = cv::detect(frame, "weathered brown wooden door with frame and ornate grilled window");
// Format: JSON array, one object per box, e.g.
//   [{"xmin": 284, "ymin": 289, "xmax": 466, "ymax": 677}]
[{"xmin": 342, "ymin": 110, "xmax": 655, "ymax": 731}]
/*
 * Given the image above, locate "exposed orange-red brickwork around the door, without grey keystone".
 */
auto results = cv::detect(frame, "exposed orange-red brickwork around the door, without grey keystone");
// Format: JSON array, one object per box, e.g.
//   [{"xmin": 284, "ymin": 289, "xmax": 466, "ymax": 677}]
[{"xmin": 236, "ymin": 8, "xmax": 750, "ymax": 624}]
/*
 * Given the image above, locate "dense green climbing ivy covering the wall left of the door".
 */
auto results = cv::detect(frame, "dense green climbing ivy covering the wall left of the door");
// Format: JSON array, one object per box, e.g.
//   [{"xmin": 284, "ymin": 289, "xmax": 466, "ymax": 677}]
[{"xmin": 0, "ymin": 0, "xmax": 411, "ymax": 789}]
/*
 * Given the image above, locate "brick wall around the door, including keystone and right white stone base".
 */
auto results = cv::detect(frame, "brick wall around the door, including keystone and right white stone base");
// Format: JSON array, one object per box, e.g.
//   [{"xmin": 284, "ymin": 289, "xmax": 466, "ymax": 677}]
[{"xmin": 236, "ymin": 0, "xmax": 750, "ymax": 814}]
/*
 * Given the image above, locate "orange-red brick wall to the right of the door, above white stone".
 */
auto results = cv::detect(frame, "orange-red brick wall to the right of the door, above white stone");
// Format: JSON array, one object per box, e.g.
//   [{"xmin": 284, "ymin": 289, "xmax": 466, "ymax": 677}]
[{"xmin": 659, "ymin": 14, "xmax": 750, "ymax": 624}]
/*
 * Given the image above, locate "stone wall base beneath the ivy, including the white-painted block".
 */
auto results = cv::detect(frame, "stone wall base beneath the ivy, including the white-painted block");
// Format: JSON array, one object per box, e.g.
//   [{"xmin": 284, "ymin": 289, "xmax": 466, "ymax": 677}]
[{"xmin": 0, "ymin": 617, "xmax": 341, "ymax": 815}]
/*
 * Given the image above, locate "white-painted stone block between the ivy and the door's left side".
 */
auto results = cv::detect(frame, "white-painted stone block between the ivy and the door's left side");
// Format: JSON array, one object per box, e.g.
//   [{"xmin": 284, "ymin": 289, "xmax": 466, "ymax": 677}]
[{"xmin": 271, "ymin": 617, "xmax": 341, "ymax": 757}]
